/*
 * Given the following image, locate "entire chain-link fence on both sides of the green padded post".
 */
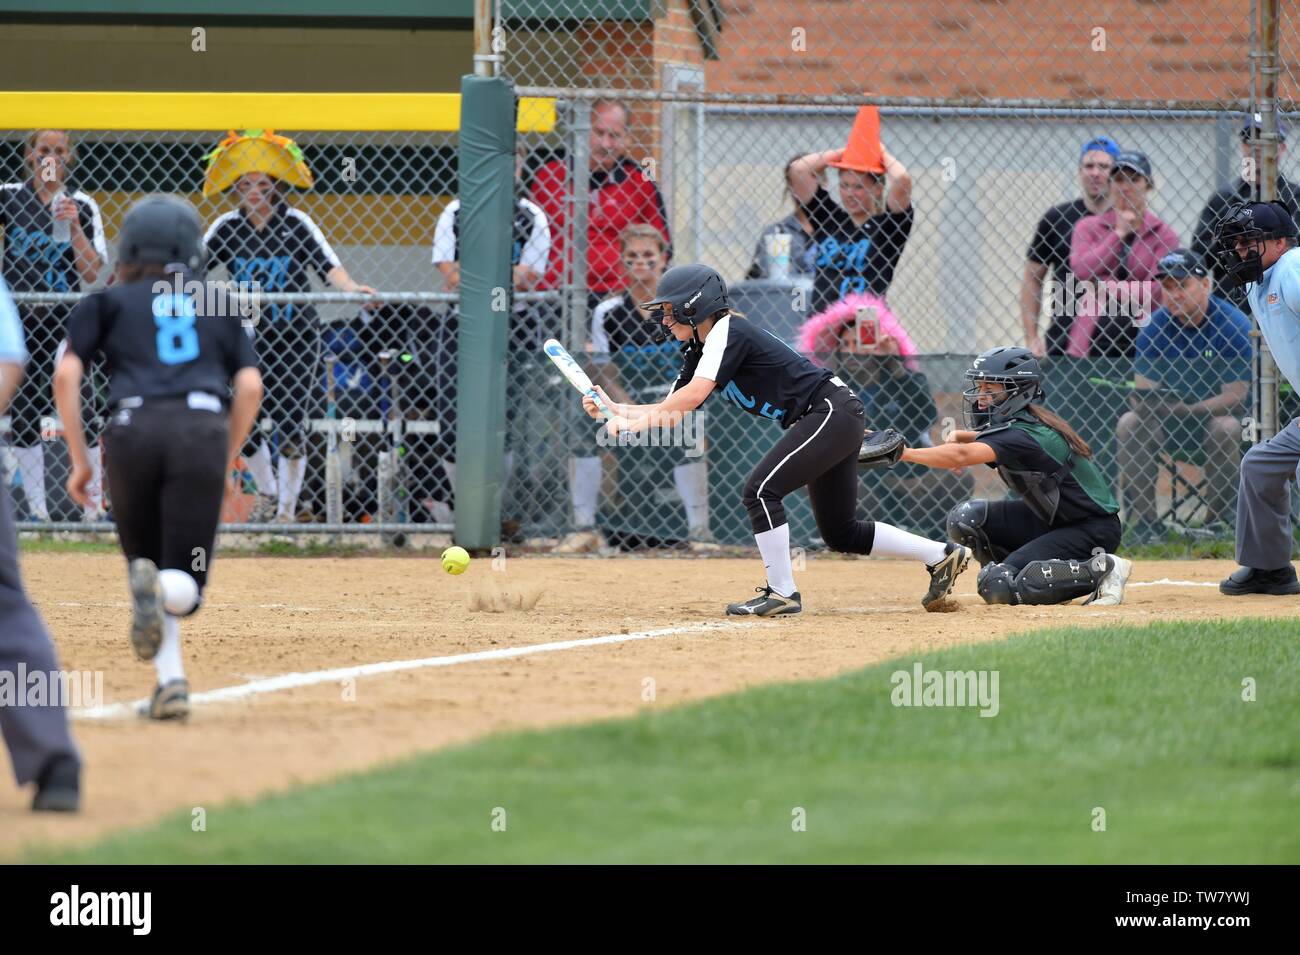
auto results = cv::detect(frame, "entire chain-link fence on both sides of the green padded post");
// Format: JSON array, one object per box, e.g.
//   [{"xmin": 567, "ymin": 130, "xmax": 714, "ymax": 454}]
[{"xmin": 0, "ymin": 0, "xmax": 1300, "ymax": 552}]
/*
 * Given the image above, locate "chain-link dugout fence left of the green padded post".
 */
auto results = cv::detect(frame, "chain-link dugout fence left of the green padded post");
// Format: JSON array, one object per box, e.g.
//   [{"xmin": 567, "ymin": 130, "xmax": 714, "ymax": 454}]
[{"xmin": 0, "ymin": 130, "xmax": 506, "ymax": 530}]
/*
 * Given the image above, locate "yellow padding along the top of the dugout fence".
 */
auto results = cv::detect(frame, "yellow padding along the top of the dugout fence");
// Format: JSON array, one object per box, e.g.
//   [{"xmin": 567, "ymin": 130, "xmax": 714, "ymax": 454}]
[{"xmin": 0, "ymin": 91, "xmax": 555, "ymax": 133}]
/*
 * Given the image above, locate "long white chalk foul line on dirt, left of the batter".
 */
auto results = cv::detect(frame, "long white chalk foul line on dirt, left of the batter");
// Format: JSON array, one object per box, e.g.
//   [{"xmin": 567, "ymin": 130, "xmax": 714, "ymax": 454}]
[{"xmin": 72, "ymin": 621, "xmax": 755, "ymax": 720}]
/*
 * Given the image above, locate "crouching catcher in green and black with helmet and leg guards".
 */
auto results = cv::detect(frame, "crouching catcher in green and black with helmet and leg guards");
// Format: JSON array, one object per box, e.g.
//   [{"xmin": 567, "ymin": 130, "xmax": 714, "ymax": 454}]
[{"xmin": 902, "ymin": 346, "xmax": 1132, "ymax": 607}]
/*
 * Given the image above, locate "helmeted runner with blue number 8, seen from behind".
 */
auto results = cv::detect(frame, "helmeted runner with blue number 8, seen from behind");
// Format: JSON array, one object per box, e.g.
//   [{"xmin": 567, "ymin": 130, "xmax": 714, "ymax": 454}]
[{"xmin": 55, "ymin": 196, "xmax": 261, "ymax": 720}]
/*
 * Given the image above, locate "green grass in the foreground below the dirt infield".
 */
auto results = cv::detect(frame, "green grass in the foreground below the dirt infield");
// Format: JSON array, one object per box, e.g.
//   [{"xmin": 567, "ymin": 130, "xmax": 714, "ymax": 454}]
[{"xmin": 33, "ymin": 620, "xmax": 1300, "ymax": 863}]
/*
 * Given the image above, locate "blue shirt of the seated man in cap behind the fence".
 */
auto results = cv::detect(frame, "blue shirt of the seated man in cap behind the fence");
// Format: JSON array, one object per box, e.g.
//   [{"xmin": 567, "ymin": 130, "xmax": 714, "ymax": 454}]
[{"xmin": 1134, "ymin": 295, "xmax": 1251, "ymax": 401}]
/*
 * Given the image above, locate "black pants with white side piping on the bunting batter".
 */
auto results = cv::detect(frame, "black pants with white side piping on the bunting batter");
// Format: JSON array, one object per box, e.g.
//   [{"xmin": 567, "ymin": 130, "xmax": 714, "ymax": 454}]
[{"xmin": 744, "ymin": 382, "xmax": 876, "ymax": 554}]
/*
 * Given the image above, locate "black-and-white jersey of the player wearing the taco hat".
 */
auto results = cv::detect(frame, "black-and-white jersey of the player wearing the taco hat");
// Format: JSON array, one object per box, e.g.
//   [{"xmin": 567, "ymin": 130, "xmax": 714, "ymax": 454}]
[{"xmin": 203, "ymin": 201, "xmax": 342, "ymax": 322}]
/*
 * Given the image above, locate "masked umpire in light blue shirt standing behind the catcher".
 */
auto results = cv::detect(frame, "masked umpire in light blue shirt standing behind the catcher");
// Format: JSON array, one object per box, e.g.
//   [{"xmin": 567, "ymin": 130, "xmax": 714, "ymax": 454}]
[{"xmin": 1214, "ymin": 201, "xmax": 1300, "ymax": 596}]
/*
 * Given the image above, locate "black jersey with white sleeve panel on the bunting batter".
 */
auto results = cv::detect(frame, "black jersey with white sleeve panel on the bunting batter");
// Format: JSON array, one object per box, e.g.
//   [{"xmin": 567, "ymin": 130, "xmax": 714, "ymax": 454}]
[{"xmin": 672, "ymin": 314, "xmax": 832, "ymax": 427}]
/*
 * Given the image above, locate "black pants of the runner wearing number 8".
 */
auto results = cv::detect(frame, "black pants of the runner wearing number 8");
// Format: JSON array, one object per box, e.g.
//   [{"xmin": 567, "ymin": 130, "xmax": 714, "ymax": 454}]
[{"xmin": 104, "ymin": 398, "xmax": 229, "ymax": 591}]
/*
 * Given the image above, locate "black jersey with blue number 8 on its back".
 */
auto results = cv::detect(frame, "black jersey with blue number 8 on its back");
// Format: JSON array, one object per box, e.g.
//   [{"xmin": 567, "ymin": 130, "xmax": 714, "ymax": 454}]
[{"xmin": 68, "ymin": 275, "xmax": 257, "ymax": 405}]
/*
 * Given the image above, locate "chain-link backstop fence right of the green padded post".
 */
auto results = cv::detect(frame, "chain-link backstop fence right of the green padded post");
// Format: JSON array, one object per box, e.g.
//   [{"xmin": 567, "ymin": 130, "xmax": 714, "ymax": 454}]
[{"xmin": 494, "ymin": 0, "xmax": 1300, "ymax": 551}]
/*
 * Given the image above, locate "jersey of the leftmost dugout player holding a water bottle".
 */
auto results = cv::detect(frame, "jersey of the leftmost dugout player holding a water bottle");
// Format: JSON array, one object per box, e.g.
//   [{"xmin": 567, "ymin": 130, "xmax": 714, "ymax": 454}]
[{"xmin": 0, "ymin": 182, "xmax": 108, "ymax": 292}]
